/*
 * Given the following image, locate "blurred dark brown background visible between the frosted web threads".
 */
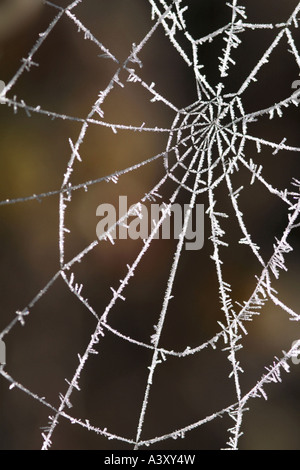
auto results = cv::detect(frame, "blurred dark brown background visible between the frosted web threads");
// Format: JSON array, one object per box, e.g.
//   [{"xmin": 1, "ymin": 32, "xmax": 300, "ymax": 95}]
[{"xmin": 0, "ymin": 0, "xmax": 300, "ymax": 450}]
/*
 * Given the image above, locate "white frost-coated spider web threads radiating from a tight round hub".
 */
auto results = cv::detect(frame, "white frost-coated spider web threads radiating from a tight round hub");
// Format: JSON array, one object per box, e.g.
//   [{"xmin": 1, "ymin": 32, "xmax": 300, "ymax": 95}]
[{"xmin": 0, "ymin": 0, "xmax": 300, "ymax": 449}]
